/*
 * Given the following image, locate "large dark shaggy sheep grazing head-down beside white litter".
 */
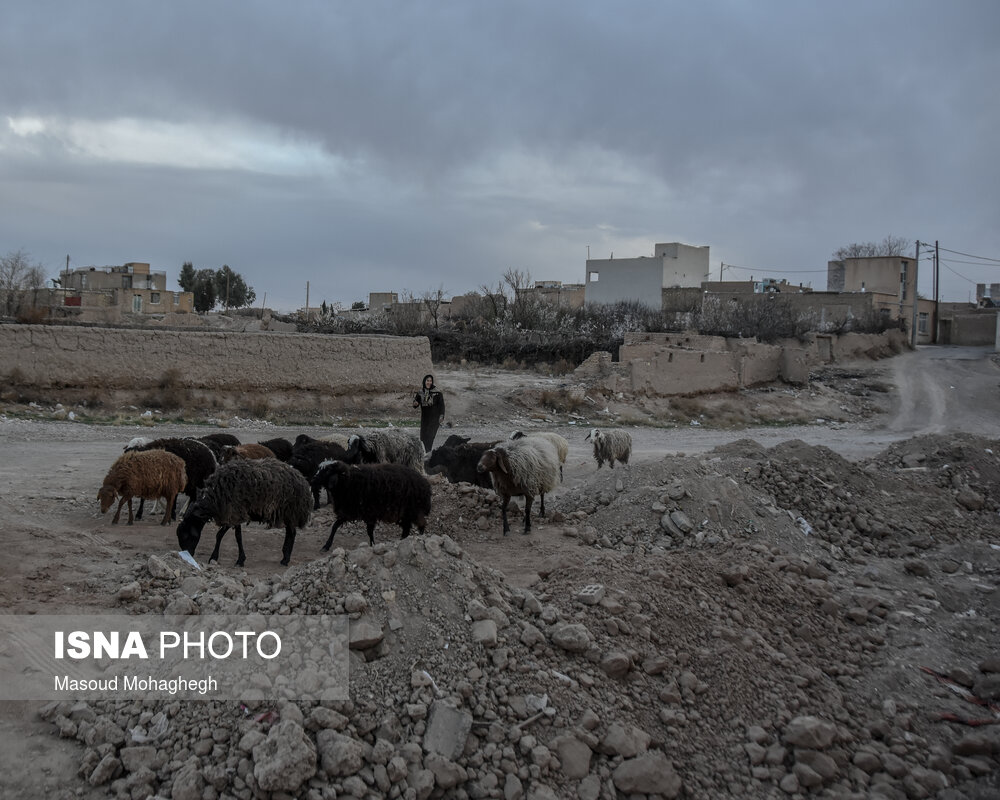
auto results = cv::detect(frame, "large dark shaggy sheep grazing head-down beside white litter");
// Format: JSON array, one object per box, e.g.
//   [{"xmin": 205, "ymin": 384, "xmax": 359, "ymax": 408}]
[{"xmin": 177, "ymin": 458, "xmax": 312, "ymax": 567}]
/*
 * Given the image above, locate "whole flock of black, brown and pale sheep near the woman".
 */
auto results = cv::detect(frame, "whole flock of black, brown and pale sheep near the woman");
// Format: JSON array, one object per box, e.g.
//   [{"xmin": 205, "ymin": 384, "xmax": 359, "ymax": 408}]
[{"xmin": 97, "ymin": 428, "xmax": 632, "ymax": 566}]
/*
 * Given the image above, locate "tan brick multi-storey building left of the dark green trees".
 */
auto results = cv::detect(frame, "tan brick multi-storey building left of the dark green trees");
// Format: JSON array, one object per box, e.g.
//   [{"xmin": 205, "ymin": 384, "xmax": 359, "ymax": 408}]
[{"xmin": 59, "ymin": 261, "xmax": 194, "ymax": 314}]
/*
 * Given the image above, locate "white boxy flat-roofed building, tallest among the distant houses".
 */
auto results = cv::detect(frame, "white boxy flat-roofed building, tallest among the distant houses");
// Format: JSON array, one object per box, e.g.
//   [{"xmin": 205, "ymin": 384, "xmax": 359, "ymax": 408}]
[{"xmin": 585, "ymin": 242, "xmax": 709, "ymax": 307}]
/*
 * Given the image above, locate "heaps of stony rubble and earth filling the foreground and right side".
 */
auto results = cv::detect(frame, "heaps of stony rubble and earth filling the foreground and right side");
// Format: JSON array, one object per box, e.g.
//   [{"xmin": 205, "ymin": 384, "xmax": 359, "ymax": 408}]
[{"xmin": 35, "ymin": 440, "xmax": 1000, "ymax": 800}]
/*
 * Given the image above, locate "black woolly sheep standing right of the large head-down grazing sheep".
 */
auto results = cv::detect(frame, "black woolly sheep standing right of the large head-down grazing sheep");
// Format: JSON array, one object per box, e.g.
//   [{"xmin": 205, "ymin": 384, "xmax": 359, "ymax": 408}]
[{"xmin": 312, "ymin": 461, "xmax": 431, "ymax": 550}]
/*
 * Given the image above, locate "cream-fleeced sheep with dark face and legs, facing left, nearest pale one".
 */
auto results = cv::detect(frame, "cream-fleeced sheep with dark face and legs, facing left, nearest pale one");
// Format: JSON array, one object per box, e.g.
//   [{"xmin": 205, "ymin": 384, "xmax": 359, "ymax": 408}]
[{"xmin": 476, "ymin": 436, "xmax": 559, "ymax": 536}]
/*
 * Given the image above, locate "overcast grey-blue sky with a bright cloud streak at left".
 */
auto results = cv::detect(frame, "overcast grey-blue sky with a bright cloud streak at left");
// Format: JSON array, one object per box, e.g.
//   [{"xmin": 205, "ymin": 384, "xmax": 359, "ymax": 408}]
[{"xmin": 0, "ymin": 0, "xmax": 1000, "ymax": 310}]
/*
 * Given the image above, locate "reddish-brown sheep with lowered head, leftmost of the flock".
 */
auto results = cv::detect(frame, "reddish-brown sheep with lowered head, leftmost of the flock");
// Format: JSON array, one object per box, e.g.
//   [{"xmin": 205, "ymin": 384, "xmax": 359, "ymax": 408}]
[{"xmin": 97, "ymin": 450, "xmax": 187, "ymax": 525}]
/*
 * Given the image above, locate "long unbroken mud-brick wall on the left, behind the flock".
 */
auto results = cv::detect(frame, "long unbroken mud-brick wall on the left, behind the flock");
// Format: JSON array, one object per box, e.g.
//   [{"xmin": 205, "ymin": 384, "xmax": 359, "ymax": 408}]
[{"xmin": 0, "ymin": 325, "xmax": 432, "ymax": 395}]
